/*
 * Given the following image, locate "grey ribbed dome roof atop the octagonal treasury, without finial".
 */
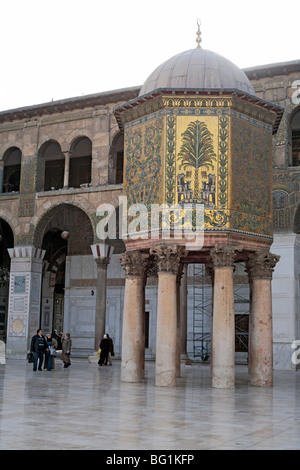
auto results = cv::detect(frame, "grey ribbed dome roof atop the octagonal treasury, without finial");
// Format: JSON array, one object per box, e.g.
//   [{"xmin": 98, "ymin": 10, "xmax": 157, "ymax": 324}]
[{"xmin": 139, "ymin": 47, "xmax": 255, "ymax": 96}]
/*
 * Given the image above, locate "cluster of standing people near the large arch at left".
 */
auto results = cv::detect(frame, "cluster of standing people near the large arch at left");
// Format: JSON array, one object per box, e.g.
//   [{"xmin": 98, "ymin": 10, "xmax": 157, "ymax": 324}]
[{"xmin": 30, "ymin": 328, "xmax": 72, "ymax": 371}]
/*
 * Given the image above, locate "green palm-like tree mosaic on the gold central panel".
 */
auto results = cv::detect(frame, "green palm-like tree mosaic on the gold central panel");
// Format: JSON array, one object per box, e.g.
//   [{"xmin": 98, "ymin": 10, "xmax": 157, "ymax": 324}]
[{"xmin": 178, "ymin": 120, "xmax": 216, "ymax": 199}]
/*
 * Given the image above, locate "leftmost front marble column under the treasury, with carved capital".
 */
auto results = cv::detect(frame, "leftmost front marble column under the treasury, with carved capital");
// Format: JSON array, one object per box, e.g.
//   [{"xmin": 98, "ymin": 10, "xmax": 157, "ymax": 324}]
[{"xmin": 119, "ymin": 251, "xmax": 149, "ymax": 382}]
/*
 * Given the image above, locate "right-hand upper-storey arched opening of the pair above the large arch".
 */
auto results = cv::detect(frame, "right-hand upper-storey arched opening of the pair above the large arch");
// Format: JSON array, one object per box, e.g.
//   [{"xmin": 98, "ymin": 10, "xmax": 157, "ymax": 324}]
[{"xmin": 69, "ymin": 137, "xmax": 92, "ymax": 188}]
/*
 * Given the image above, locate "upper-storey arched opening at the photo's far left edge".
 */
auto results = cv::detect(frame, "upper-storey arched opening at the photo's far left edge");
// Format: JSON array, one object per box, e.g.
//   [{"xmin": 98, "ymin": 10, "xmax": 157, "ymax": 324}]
[{"xmin": 3, "ymin": 147, "xmax": 22, "ymax": 193}]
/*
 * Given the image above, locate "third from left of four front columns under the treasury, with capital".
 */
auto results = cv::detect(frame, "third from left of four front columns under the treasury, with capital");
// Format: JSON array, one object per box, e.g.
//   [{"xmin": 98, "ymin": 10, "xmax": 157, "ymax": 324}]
[{"xmin": 210, "ymin": 246, "xmax": 237, "ymax": 388}]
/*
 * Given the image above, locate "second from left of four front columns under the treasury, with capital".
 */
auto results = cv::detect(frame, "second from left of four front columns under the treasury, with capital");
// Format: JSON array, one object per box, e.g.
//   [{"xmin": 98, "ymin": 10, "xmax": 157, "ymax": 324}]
[{"xmin": 150, "ymin": 245, "xmax": 185, "ymax": 386}]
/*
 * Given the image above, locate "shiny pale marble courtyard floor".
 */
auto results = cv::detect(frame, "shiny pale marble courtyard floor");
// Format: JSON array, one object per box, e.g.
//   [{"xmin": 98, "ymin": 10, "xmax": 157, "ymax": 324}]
[{"xmin": 0, "ymin": 359, "xmax": 300, "ymax": 451}]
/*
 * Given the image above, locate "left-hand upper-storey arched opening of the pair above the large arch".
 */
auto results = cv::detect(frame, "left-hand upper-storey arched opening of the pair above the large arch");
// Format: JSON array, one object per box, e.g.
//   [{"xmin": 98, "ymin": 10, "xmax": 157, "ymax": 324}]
[{"xmin": 37, "ymin": 140, "xmax": 65, "ymax": 191}]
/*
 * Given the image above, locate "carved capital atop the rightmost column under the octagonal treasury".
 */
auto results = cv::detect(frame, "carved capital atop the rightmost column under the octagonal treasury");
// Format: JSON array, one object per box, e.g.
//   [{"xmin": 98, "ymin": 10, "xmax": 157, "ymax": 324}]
[{"xmin": 247, "ymin": 251, "xmax": 280, "ymax": 279}]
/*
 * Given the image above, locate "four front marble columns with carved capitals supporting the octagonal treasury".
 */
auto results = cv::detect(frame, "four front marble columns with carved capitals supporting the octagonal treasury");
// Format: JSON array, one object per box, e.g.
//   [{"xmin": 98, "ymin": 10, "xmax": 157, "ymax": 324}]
[{"xmin": 120, "ymin": 244, "xmax": 279, "ymax": 388}]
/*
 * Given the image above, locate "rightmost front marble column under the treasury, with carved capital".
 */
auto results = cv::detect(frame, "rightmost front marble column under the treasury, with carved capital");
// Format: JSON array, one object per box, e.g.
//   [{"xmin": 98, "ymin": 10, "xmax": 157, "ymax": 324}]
[{"xmin": 247, "ymin": 252, "xmax": 280, "ymax": 386}]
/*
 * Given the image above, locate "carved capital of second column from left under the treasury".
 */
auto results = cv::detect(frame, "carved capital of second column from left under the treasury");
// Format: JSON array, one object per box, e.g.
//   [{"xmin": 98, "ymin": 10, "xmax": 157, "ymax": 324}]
[{"xmin": 150, "ymin": 245, "xmax": 186, "ymax": 275}]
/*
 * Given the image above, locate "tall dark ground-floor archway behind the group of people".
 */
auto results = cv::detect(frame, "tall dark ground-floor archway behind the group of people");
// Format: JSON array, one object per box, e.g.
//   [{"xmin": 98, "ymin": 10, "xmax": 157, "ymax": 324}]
[{"xmin": 34, "ymin": 204, "xmax": 94, "ymax": 340}]
